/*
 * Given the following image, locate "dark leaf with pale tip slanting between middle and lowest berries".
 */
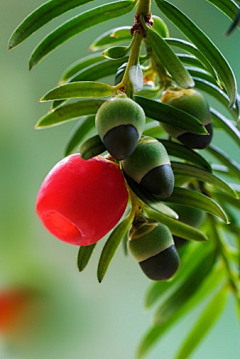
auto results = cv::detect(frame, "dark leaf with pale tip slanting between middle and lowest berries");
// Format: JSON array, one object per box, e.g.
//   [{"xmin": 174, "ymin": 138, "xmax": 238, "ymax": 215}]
[{"xmin": 124, "ymin": 174, "xmax": 178, "ymax": 219}]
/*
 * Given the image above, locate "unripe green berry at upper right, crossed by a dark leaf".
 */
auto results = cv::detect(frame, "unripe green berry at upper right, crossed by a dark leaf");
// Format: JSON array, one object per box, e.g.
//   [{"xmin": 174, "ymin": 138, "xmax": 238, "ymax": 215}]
[{"xmin": 161, "ymin": 88, "xmax": 213, "ymax": 149}]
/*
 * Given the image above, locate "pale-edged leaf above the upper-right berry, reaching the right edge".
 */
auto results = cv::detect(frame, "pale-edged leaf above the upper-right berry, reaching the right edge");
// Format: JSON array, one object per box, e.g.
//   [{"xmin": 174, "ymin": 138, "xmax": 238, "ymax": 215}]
[{"xmin": 194, "ymin": 77, "xmax": 239, "ymax": 121}]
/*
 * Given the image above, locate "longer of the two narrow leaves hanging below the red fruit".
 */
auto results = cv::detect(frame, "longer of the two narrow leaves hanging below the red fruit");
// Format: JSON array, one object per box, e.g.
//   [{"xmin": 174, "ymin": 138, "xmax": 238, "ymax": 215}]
[{"xmin": 97, "ymin": 214, "xmax": 133, "ymax": 283}]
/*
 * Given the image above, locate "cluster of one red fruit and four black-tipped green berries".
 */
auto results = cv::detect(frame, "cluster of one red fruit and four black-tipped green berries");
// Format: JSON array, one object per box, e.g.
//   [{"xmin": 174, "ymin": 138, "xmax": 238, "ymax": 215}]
[{"xmin": 37, "ymin": 83, "xmax": 212, "ymax": 280}]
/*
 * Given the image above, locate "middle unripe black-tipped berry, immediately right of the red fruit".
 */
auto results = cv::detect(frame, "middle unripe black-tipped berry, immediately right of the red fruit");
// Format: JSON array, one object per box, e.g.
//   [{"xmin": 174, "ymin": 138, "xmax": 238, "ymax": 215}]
[{"xmin": 122, "ymin": 136, "xmax": 174, "ymax": 198}]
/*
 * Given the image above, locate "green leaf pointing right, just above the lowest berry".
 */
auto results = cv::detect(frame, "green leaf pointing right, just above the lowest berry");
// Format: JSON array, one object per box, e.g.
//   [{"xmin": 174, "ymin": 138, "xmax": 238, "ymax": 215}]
[{"xmin": 144, "ymin": 207, "xmax": 208, "ymax": 242}]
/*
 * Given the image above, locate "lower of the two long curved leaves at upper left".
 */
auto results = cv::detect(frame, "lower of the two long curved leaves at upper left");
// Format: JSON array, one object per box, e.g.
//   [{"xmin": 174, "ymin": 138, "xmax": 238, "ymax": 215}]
[{"xmin": 29, "ymin": 0, "xmax": 136, "ymax": 69}]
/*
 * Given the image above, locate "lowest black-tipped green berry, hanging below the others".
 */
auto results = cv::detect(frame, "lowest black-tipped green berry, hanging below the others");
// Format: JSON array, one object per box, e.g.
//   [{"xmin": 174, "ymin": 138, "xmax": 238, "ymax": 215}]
[{"xmin": 129, "ymin": 220, "xmax": 180, "ymax": 281}]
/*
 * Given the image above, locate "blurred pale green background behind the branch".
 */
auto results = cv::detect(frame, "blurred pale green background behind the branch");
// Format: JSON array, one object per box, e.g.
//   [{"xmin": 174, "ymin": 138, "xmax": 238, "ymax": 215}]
[{"xmin": 0, "ymin": 0, "xmax": 240, "ymax": 359}]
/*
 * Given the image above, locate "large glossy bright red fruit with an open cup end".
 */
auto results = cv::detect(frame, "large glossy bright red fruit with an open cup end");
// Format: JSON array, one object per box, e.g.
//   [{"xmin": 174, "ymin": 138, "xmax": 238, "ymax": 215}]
[{"xmin": 36, "ymin": 154, "xmax": 128, "ymax": 246}]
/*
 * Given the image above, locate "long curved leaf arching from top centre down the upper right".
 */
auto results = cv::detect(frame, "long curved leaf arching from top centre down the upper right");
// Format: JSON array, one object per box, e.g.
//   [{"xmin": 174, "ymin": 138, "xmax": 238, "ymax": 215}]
[{"xmin": 155, "ymin": 0, "xmax": 237, "ymax": 108}]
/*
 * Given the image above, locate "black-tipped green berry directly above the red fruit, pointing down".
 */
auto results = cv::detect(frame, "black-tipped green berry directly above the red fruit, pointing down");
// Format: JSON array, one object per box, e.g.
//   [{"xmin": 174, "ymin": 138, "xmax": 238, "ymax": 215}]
[{"xmin": 96, "ymin": 96, "xmax": 145, "ymax": 161}]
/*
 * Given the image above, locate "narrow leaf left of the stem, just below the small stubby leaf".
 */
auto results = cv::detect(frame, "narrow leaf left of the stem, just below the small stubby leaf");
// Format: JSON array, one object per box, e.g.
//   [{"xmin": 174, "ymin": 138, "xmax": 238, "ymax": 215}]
[{"xmin": 69, "ymin": 57, "xmax": 128, "ymax": 82}]
